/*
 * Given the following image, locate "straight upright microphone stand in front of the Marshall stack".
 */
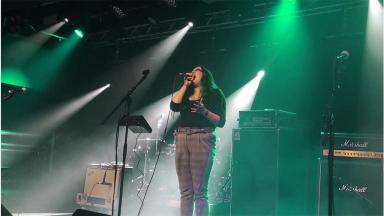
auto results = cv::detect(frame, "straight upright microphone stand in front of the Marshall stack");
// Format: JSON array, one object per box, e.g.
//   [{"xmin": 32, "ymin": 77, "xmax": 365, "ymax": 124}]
[{"xmin": 327, "ymin": 57, "xmax": 343, "ymax": 216}]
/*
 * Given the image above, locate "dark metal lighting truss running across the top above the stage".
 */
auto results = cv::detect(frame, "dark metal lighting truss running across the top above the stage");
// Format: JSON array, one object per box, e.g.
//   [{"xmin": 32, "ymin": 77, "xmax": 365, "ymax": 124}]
[{"xmin": 88, "ymin": 0, "xmax": 368, "ymax": 47}]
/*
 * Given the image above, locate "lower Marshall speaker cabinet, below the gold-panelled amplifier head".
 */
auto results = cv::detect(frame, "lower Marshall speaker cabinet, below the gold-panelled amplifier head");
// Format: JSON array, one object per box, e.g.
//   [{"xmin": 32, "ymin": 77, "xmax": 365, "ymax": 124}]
[{"xmin": 317, "ymin": 158, "xmax": 383, "ymax": 216}]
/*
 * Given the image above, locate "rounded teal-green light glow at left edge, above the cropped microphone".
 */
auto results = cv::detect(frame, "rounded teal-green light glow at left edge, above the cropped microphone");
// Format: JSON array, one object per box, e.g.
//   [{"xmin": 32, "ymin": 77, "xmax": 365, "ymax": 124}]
[{"xmin": 1, "ymin": 68, "xmax": 30, "ymax": 87}]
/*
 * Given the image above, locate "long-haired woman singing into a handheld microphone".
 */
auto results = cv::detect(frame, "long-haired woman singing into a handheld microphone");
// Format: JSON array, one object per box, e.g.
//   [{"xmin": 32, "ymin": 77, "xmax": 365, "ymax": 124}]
[{"xmin": 171, "ymin": 66, "xmax": 226, "ymax": 216}]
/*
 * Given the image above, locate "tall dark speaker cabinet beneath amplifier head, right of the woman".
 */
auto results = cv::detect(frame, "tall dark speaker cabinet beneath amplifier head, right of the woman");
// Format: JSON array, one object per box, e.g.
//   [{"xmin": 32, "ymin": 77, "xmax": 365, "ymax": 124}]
[{"xmin": 231, "ymin": 128, "xmax": 303, "ymax": 216}]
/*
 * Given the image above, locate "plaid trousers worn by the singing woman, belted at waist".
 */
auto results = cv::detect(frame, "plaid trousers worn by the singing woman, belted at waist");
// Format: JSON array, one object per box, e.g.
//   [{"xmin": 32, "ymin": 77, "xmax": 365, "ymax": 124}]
[{"xmin": 175, "ymin": 127, "xmax": 216, "ymax": 216}]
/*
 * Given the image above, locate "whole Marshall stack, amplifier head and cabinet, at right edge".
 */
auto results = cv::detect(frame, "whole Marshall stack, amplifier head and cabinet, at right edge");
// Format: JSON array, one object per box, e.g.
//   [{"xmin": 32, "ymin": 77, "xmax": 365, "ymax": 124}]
[{"xmin": 317, "ymin": 133, "xmax": 383, "ymax": 216}]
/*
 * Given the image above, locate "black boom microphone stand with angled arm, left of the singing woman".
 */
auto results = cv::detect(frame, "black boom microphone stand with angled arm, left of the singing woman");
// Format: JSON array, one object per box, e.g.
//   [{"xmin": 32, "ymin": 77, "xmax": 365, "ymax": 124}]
[{"xmin": 101, "ymin": 69, "xmax": 149, "ymax": 216}]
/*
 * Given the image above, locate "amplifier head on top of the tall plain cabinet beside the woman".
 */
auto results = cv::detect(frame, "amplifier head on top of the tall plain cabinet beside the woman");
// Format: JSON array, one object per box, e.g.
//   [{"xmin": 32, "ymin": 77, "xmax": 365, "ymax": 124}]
[{"xmin": 239, "ymin": 109, "xmax": 296, "ymax": 128}]
